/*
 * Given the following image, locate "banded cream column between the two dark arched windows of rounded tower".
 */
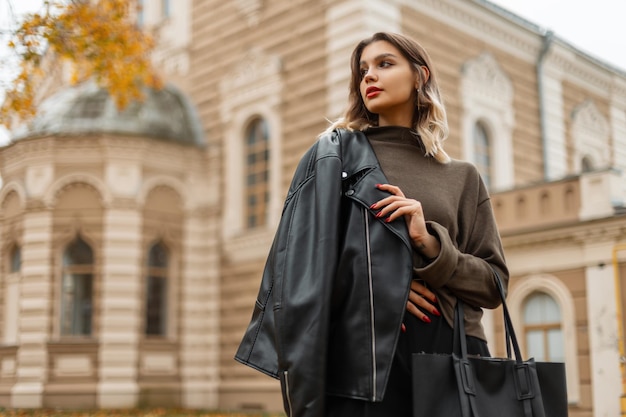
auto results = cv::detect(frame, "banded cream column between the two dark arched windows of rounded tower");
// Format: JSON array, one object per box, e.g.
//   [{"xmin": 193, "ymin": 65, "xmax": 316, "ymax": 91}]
[{"xmin": 98, "ymin": 208, "xmax": 142, "ymax": 408}]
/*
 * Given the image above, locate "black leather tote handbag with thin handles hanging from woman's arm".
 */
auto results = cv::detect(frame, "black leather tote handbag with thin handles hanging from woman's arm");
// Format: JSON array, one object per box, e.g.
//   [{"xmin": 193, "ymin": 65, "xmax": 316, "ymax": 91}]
[{"xmin": 412, "ymin": 270, "xmax": 567, "ymax": 417}]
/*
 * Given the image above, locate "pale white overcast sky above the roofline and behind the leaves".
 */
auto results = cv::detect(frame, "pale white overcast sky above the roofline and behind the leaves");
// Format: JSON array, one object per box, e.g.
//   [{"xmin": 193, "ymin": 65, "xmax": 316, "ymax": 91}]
[{"xmin": 0, "ymin": 0, "xmax": 626, "ymax": 145}]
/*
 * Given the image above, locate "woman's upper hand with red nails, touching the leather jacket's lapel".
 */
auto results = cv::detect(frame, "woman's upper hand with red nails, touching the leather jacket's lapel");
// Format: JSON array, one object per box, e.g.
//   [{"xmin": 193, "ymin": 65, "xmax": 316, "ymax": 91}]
[{"xmin": 370, "ymin": 184, "xmax": 441, "ymax": 258}]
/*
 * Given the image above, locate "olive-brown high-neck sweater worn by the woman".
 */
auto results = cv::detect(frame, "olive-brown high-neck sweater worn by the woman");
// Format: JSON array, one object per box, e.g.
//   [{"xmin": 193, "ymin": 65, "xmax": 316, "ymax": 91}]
[{"xmin": 364, "ymin": 126, "xmax": 508, "ymax": 340}]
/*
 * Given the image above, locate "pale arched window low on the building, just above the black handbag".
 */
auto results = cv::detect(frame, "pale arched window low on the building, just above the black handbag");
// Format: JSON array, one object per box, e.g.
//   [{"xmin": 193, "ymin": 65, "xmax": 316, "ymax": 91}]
[{"xmin": 523, "ymin": 292, "xmax": 565, "ymax": 362}]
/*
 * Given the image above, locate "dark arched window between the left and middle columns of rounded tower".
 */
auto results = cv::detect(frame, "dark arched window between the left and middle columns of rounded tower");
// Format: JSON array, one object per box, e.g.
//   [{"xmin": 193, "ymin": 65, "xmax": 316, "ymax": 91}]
[{"xmin": 61, "ymin": 237, "xmax": 94, "ymax": 336}]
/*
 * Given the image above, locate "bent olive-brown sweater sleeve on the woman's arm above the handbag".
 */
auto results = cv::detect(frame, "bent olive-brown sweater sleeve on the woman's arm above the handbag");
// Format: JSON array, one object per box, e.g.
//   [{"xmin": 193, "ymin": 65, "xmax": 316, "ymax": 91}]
[{"xmin": 415, "ymin": 198, "xmax": 509, "ymax": 308}]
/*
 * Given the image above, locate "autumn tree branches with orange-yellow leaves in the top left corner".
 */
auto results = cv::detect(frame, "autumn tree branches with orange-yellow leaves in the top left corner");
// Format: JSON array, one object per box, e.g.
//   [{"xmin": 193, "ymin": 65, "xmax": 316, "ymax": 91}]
[{"xmin": 0, "ymin": 0, "xmax": 160, "ymax": 127}]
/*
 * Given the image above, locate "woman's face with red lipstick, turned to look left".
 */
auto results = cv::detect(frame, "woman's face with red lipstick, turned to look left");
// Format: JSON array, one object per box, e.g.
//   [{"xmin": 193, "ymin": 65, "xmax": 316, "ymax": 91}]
[{"xmin": 360, "ymin": 41, "xmax": 419, "ymax": 127}]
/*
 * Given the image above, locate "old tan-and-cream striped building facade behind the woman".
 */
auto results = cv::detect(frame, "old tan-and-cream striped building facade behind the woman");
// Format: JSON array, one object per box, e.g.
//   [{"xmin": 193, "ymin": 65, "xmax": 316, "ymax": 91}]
[{"xmin": 0, "ymin": 0, "xmax": 626, "ymax": 417}]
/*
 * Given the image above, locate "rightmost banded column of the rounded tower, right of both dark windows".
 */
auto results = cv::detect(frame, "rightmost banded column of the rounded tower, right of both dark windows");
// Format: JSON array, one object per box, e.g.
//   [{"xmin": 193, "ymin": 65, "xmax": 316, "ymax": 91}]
[{"xmin": 180, "ymin": 210, "xmax": 220, "ymax": 408}]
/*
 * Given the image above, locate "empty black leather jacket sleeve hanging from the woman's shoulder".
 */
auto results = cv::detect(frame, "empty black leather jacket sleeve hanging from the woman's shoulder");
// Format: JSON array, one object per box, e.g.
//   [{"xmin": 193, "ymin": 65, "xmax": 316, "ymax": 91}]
[{"xmin": 271, "ymin": 139, "xmax": 342, "ymax": 417}]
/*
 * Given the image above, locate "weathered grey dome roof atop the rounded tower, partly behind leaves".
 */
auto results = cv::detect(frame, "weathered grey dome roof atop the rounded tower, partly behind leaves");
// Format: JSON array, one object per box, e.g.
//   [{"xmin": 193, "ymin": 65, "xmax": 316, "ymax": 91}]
[{"xmin": 13, "ymin": 82, "xmax": 206, "ymax": 147}]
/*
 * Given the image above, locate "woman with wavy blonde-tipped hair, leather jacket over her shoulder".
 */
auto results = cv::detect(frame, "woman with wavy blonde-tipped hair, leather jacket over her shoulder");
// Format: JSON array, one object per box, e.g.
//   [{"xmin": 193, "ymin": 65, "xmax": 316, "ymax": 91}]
[{"xmin": 236, "ymin": 33, "xmax": 508, "ymax": 417}]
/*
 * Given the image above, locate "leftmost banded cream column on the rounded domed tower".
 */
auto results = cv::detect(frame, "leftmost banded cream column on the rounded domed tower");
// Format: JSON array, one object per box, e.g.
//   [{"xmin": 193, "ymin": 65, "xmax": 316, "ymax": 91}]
[{"xmin": 11, "ymin": 208, "xmax": 54, "ymax": 408}]
